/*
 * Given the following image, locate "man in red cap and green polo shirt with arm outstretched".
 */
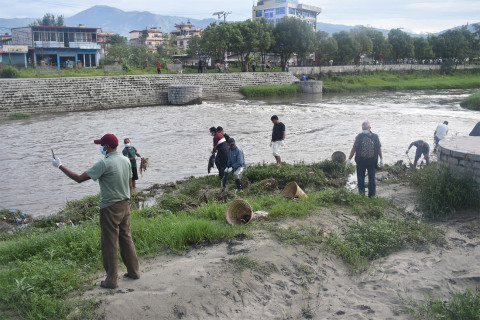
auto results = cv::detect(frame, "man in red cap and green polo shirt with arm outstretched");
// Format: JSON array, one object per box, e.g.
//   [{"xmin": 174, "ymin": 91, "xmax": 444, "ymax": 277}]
[{"xmin": 52, "ymin": 133, "xmax": 140, "ymax": 289}]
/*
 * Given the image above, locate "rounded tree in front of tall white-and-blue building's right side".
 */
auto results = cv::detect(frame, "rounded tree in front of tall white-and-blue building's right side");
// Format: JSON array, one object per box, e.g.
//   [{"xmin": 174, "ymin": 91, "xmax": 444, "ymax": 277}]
[{"xmin": 273, "ymin": 17, "xmax": 315, "ymax": 66}]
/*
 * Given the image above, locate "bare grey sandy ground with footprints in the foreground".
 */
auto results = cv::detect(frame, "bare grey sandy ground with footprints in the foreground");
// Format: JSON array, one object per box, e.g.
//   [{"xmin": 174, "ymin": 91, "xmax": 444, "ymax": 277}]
[{"xmin": 85, "ymin": 185, "xmax": 480, "ymax": 319}]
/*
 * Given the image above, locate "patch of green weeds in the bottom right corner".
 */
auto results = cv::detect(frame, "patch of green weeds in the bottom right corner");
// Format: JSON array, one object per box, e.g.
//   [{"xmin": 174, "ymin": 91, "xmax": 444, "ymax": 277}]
[{"xmin": 406, "ymin": 288, "xmax": 480, "ymax": 320}]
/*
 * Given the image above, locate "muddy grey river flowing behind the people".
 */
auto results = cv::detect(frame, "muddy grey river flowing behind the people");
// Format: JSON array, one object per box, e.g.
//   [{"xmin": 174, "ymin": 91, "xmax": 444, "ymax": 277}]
[{"xmin": 0, "ymin": 90, "xmax": 480, "ymax": 216}]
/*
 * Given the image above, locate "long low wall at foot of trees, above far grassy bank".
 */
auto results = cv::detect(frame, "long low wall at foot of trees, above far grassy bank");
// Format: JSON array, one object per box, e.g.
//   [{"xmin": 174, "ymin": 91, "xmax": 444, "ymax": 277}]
[{"xmin": 288, "ymin": 64, "xmax": 480, "ymax": 75}]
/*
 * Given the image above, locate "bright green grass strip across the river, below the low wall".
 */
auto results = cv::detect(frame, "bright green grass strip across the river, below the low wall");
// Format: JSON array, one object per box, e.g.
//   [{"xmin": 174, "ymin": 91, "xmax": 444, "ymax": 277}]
[{"xmin": 319, "ymin": 71, "xmax": 480, "ymax": 93}]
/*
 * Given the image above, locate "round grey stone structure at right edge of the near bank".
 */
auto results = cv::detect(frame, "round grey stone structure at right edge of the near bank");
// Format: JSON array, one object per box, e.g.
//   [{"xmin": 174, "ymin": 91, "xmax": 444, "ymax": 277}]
[{"xmin": 438, "ymin": 136, "xmax": 480, "ymax": 192}]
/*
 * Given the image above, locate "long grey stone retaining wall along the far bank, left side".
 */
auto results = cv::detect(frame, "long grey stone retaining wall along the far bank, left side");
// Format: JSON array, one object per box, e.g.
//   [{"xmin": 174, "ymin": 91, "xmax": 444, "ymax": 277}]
[{"xmin": 0, "ymin": 72, "xmax": 298, "ymax": 117}]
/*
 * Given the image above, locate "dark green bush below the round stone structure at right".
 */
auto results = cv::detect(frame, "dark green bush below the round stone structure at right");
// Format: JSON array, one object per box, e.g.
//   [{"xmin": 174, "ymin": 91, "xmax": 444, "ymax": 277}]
[{"xmin": 410, "ymin": 163, "xmax": 480, "ymax": 219}]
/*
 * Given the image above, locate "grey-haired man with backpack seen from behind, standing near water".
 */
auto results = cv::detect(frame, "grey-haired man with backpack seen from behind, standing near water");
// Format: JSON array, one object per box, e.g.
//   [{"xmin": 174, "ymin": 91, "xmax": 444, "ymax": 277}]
[{"xmin": 346, "ymin": 121, "xmax": 383, "ymax": 198}]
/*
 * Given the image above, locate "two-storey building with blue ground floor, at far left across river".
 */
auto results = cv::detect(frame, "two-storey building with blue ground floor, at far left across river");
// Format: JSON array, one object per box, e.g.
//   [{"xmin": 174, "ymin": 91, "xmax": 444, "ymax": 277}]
[{"xmin": 12, "ymin": 26, "xmax": 100, "ymax": 68}]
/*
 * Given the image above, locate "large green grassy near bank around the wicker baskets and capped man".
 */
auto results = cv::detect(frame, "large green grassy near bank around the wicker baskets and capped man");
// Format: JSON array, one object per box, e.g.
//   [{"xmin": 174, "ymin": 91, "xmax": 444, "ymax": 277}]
[{"xmin": 0, "ymin": 161, "xmax": 443, "ymax": 319}]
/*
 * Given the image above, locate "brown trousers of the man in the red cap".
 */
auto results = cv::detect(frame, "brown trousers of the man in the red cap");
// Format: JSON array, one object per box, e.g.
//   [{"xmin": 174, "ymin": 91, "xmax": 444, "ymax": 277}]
[{"xmin": 100, "ymin": 201, "xmax": 140, "ymax": 286}]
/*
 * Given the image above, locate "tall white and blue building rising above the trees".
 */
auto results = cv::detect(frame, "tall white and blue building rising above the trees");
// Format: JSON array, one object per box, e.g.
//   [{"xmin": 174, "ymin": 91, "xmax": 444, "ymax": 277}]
[{"xmin": 252, "ymin": 0, "xmax": 322, "ymax": 31}]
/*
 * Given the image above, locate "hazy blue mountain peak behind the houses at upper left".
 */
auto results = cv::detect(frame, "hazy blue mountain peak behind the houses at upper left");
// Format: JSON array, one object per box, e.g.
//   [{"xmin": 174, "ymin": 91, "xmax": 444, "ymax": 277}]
[{"xmin": 65, "ymin": 6, "xmax": 216, "ymax": 37}]
